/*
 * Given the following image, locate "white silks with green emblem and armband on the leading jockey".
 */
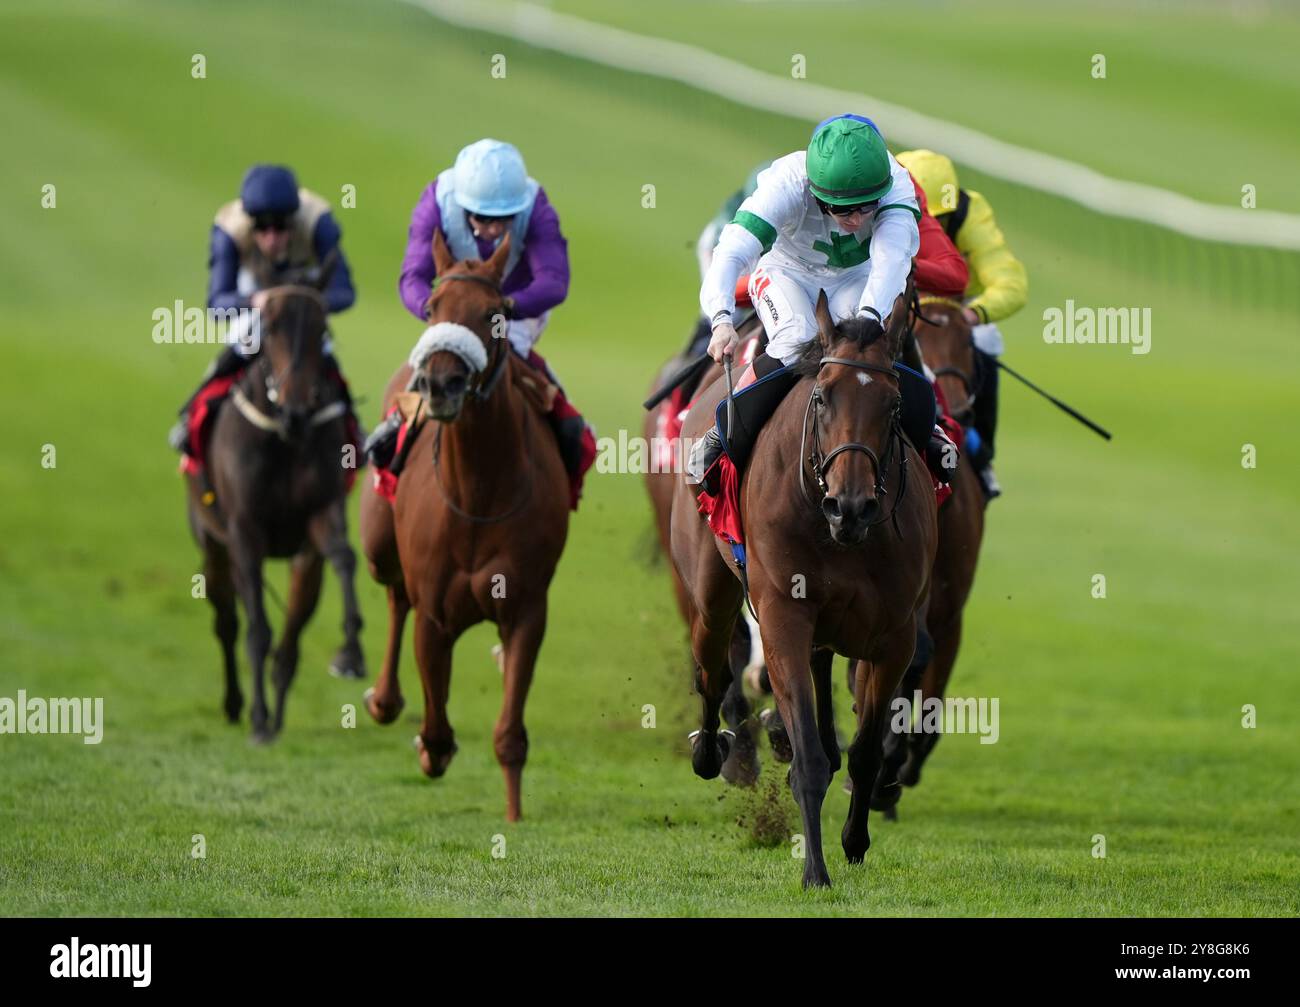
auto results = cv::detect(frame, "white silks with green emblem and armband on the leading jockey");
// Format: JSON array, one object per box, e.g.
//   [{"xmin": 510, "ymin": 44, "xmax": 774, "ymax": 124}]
[{"xmin": 699, "ymin": 151, "xmax": 920, "ymax": 327}]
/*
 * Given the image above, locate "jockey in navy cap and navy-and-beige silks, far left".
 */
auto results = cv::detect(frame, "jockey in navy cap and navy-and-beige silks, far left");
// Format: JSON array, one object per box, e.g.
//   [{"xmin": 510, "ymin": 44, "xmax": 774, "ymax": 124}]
[{"xmin": 169, "ymin": 164, "xmax": 356, "ymax": 455}]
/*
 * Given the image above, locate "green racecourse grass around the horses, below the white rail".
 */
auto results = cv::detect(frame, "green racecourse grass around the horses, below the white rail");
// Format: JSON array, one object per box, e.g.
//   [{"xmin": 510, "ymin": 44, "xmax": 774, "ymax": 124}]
[{"xmin": 0, "ymin": 3, "xmax": 1300, "ymax": 916}]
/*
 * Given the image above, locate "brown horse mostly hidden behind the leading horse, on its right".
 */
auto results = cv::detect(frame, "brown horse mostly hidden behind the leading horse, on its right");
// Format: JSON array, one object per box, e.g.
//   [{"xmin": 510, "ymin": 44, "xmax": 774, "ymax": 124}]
[{"xmin": 875, "ymin": 298, "xmax": 987, "ymax": 807}]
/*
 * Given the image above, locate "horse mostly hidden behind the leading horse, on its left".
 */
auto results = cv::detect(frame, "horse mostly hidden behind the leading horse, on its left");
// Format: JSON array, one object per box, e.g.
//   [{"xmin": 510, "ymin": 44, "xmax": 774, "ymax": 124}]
[{"xmin": 641, "ymin": 327, "xmax": 762, "ymax": 786}]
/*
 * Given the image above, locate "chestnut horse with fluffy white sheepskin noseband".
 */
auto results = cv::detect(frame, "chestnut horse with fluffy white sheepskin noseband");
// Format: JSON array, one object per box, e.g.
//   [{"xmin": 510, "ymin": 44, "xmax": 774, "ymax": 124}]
[{"xmin": 360, "ymin": 231, "xmax": 569, "ymax": 821}]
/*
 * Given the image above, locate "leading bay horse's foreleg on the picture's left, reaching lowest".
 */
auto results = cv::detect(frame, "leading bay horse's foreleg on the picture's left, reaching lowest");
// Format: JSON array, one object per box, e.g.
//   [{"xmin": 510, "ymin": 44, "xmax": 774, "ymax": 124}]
[{"xmin": 763, "ymin": 608, "xmax": 831, "ymax": 887}]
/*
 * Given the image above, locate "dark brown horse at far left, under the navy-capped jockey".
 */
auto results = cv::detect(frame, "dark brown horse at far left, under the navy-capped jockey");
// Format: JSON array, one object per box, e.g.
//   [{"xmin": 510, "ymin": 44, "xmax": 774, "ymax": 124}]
[{"xmin": 186, "ymin": 268, "xmax": 365, "ymax": 743}]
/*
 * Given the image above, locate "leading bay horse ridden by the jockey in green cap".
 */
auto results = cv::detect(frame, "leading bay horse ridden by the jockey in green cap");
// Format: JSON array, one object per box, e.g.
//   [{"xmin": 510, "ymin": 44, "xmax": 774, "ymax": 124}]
[{"xmin": 671, "ymin": 292, "xmax": 937, "ymax": 887}]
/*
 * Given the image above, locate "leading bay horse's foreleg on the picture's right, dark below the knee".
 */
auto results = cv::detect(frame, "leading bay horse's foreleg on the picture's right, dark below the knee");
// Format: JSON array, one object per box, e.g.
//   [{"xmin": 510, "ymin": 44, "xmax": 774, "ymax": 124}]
[{"xmin": 840, "ymin": 620, "xmax": 917, "ymax": 864}]
